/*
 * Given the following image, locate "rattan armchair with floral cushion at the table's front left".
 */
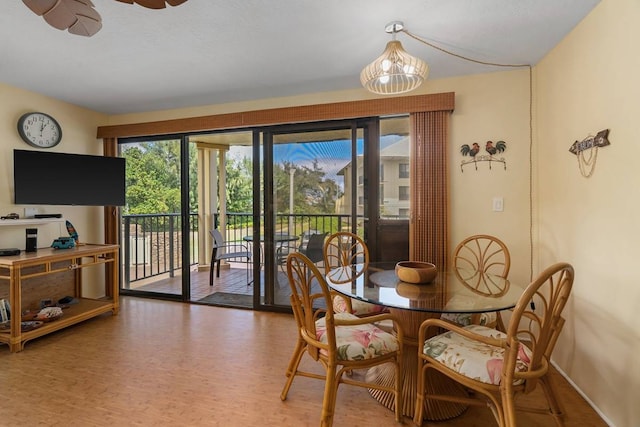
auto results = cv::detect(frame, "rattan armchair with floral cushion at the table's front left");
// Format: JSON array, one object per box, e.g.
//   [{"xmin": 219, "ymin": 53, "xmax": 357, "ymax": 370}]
[{"xmin": 280, "ymin": 252, "xmax": 404, "ymax": 426}]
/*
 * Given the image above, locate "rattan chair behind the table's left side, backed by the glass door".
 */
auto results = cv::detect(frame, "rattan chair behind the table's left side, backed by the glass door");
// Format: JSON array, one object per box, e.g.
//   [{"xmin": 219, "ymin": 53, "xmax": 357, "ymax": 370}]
[{"xmin": 323, "ymin": 231, "xmax": 387, "ymax": 317}]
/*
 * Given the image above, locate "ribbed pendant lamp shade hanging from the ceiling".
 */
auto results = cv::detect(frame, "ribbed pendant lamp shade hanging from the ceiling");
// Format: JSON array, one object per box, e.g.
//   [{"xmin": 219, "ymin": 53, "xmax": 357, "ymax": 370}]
[{"xmin": 360, "ymin": 40, "xmax": 429, "ymax": 95}]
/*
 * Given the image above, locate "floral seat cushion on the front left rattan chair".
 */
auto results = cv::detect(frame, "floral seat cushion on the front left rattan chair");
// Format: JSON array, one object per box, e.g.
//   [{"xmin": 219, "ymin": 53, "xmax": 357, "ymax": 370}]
[{"xmin": 316, "ymin": 313, "xmax": 399, "ymax": 360}]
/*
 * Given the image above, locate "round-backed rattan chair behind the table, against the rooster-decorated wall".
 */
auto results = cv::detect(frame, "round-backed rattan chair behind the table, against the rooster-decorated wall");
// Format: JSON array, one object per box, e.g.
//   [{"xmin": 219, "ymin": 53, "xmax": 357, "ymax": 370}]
[{"xmin": 441, "ymin": 234, "xmax": 511, "ymax": 332}]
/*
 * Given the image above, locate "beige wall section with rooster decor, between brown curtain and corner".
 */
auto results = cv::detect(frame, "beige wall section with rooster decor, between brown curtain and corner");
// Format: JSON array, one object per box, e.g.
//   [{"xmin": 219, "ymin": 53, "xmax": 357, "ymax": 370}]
[{"xmin": 436, "ymin": 69, "xmax": 531, "ymax": 290}]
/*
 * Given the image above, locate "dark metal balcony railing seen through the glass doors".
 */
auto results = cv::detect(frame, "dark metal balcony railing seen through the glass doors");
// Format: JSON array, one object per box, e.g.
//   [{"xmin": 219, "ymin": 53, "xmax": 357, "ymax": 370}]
[{"xmin": 122, "ymin": 213, "xmax": 362, "ymax": 284}]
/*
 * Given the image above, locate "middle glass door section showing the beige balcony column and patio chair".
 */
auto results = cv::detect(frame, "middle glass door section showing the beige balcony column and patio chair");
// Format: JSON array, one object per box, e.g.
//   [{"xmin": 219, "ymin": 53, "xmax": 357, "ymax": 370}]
[{"xmin": 189, "ymin": 130, "xmax": 255, "ymax": 308}]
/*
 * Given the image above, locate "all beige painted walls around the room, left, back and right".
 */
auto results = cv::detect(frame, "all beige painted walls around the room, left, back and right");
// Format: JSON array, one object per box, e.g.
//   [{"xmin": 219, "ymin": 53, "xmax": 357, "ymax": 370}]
[{"xmin": 0, "ymin": 0, "xmax": 640, "ymax": 427}]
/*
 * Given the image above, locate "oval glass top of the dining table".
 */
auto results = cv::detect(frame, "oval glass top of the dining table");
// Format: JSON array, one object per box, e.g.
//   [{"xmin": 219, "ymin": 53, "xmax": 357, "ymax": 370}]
[{"xmin": 326, "ymin": 262, "xmax": 524, "ymax": 313}]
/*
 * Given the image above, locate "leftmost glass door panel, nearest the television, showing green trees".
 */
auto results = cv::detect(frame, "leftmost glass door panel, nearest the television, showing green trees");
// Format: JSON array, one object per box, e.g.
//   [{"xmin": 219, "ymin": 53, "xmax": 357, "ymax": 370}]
[{"xmin": 119, "ymin": 138, "xmax": 192, "ymax": 300}]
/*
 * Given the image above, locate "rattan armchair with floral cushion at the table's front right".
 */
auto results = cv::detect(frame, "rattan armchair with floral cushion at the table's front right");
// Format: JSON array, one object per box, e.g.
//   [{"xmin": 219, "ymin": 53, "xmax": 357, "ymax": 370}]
[{"xmin": 414, "ymin": 263, "xmax": 574, "ymax": 427}]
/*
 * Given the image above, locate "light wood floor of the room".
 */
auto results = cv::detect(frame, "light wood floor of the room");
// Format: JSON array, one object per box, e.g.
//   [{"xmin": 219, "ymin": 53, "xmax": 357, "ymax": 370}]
[{"xmin": 0, "ymin": 297, "xmax": 606, "ymax": 427}]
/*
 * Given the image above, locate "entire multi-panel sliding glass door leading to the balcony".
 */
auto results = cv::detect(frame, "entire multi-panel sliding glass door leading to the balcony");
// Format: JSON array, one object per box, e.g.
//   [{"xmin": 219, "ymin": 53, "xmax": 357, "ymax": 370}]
[{"xmin": 112, "ymin": 117, "xmax": 410, "ymax": 310}]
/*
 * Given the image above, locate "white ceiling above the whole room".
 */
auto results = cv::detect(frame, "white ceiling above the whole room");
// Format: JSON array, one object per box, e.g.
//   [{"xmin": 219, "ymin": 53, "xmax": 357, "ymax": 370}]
[{"xmin": 0, "ymin": 0, "xmax": 599, "ymax": 114}]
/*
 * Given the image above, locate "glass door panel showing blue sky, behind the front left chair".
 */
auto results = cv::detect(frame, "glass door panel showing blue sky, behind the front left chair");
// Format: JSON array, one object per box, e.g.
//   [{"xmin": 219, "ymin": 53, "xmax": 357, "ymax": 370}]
[{"xmin": 256, "ymin": 120, "xmax": 377, "ymax": 307}]
